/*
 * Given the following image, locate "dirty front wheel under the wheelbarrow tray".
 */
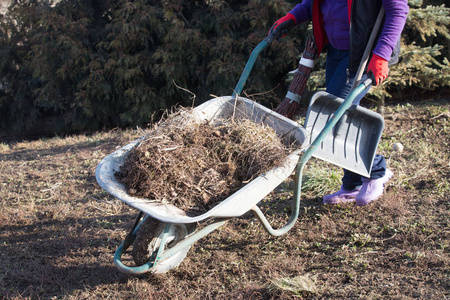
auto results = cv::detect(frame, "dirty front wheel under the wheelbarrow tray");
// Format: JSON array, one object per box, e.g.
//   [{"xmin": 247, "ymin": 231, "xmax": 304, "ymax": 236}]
[{"xmin": 132, "ymin": 216, "xmax": 195, "ymax": 273}]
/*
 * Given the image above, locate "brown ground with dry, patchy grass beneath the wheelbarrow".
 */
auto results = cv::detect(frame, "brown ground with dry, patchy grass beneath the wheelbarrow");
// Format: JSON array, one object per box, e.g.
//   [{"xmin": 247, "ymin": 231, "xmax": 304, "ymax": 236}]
[{"xmin": 0, "ymin": 100, "xmax": 450, "ymax": 299}]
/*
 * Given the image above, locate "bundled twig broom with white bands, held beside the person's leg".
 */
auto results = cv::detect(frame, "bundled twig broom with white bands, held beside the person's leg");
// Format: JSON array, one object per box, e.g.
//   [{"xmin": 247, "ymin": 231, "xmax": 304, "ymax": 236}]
[{"xmin": 275, "ymin": 37, "xmax": 317, "ymax": 120}]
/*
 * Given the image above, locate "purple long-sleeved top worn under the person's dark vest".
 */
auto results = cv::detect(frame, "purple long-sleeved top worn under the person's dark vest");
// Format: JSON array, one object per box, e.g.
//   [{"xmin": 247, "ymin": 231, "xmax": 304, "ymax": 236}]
[{"xmin": 290, "ymin": 0, "xmax": 409, "ymax": 61}]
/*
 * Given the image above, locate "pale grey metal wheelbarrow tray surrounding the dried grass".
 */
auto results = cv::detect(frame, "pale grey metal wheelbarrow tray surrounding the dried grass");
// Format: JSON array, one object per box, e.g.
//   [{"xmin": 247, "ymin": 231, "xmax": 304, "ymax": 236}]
[{"xmin": 96, "ymin": 96, "xmax": 307, "ymax": 223}]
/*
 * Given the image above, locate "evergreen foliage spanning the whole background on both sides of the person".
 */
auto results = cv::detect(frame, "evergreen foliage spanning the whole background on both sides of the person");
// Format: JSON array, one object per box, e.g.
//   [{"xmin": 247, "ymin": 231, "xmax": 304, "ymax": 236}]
[{"xmin": 0, "ymin": 0, "xmax": 450, "ymax": 135}]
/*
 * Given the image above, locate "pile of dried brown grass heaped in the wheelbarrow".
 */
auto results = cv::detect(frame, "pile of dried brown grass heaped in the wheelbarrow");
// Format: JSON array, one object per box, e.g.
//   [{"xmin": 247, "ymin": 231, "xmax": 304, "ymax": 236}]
[{"xmin": 116, "ymin": 110, "xmax": 289, "ymax": 213}]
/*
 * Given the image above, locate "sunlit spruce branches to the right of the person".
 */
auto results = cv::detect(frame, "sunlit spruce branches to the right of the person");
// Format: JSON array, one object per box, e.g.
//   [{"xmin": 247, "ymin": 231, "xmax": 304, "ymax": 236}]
[{"xmin": 372, "ymin": 0, "xmax": 450, "ymax": 98}]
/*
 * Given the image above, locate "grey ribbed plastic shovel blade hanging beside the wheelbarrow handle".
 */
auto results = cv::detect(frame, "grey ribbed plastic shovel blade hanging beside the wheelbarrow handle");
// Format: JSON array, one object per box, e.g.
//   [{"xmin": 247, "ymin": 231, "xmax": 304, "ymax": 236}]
[{"xmin": 304, "ymin": 92, "xmax": 384, "ymax": 177}]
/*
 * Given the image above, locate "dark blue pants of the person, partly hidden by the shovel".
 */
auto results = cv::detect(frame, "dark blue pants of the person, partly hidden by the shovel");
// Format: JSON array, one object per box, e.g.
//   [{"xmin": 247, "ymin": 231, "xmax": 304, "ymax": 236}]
[{"xmin": 325, "ymin": 44, "xmax": 386, "ymax": 190}]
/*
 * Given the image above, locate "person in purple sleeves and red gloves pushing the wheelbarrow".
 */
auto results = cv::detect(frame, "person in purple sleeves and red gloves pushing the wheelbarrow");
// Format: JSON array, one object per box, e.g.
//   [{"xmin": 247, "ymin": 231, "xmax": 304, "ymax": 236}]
[{"xmin": 269, "ymin": 0, "xmax": 409, "ymax": 206}]
